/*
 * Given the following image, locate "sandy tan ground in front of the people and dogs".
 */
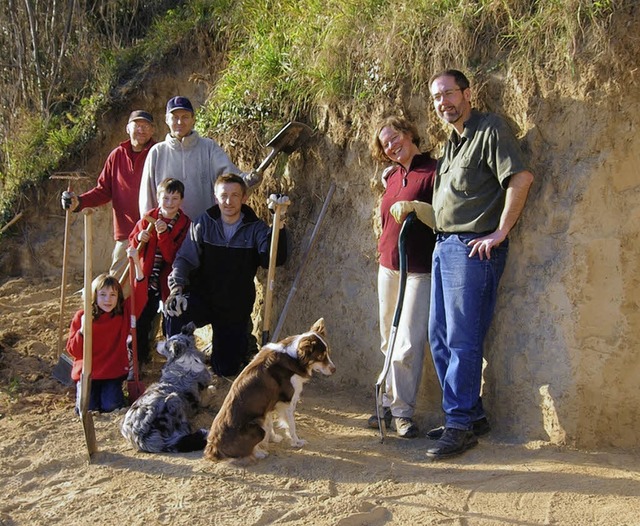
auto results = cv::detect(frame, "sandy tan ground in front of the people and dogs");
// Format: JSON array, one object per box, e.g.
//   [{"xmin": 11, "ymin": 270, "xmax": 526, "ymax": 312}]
[{"xmin": 0, "ymin": 279, "xmax": 640, "ymax": 526}]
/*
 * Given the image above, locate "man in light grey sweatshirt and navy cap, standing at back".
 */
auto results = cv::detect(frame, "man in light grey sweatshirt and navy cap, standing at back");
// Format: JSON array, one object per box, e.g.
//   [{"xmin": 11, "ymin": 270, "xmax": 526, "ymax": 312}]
[{"xmin": 138, "ymin": 96, "xmax": 260, "ymax": 218}]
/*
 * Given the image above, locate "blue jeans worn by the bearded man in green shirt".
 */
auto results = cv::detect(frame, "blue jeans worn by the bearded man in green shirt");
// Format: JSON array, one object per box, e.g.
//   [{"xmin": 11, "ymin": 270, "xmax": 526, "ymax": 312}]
[{"xmin": 429, "ymin": 233, "xmax": 509, "ymax": 429}]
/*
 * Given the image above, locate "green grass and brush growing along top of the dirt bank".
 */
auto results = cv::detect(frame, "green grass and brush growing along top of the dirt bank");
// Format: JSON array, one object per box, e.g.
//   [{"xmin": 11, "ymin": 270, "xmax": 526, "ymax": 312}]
[{"xmin": 0, "ymin": 0, "xmax": 633, "ymax": 231}]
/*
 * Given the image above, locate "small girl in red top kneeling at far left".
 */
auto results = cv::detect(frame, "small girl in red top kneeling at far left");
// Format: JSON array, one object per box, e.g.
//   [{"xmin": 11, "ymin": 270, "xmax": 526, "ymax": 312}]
[{"xmin": 67, "ymin": 247, "xmax": 147, "ymax": 413}]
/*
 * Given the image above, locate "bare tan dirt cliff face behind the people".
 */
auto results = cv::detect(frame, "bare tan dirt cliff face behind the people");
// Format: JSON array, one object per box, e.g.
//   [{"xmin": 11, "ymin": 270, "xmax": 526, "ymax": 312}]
[{"xmin": 0, "ymin": 46, "xmax": 640, "ymax": 448}]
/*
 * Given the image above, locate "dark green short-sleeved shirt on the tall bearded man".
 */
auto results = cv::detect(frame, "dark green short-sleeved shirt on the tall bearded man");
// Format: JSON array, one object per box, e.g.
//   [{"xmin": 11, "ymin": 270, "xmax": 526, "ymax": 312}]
[{"xmin": 433, "ymin": 110, "xmax": 528, "ymax": 233}]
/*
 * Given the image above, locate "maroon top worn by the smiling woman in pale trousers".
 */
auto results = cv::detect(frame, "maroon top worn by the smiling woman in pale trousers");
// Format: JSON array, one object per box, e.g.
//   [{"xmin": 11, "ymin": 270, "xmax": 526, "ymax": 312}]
[{"xmin": 378, "ymin": 153, "xmax": 437, "ymax": 273}]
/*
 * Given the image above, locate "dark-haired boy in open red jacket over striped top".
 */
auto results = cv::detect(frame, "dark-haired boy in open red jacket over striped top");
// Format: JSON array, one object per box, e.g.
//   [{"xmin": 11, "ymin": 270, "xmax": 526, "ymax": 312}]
[{"xmin": 129, "ymin": 178, "xmax": 191, "ymax": 363}]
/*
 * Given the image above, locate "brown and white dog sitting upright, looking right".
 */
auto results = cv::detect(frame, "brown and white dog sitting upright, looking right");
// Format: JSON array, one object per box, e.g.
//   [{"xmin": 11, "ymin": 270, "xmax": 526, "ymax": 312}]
[{"xmin": 204, "ymin": 318, "xmax": 336, "ymax": 461}]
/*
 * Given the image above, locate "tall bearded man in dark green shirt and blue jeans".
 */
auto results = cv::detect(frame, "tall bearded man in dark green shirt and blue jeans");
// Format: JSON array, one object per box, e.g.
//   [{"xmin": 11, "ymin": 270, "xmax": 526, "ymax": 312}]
[{"xmin": 396, "ymin": 69, "xmax": 533, "ymax": 459}]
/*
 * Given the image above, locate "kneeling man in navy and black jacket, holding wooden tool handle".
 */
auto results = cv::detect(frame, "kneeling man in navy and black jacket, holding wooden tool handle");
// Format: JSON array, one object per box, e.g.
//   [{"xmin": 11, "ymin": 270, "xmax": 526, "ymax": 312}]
[{"xmin": 166, "ymin": 174, "xmax": 288, "ymax": 376}]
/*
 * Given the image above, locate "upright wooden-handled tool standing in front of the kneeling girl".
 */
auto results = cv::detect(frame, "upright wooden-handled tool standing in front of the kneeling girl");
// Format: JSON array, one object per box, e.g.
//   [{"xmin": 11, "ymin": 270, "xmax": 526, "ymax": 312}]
[{"xmin": 79, "ymin": 208, "xmax": 98, "ymax": 462}]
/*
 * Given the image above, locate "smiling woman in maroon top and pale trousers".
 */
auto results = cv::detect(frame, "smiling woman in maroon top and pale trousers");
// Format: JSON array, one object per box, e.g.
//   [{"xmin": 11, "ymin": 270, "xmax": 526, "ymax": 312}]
[{"xmin": 368, "ymin": 117, "xmax": 436, "ymax": 438}]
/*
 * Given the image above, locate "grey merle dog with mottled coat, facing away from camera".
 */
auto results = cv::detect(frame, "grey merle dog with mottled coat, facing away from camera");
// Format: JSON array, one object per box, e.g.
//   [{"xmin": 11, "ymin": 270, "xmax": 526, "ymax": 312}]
[{"xmin": 121, "ymin": 323, "xmax": 212, "ymax": 453}]
